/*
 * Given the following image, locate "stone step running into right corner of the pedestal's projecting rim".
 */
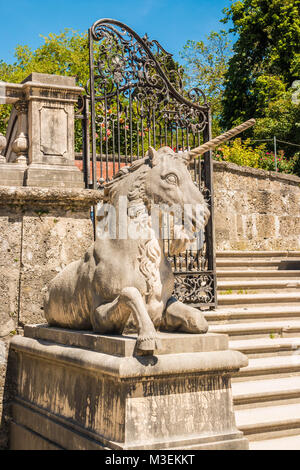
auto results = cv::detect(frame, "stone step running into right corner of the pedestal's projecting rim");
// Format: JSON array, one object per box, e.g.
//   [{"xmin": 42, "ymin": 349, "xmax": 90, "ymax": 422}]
[{"xmin": 232, "ymin": 350, "xmax": 300, "ymax": 382}]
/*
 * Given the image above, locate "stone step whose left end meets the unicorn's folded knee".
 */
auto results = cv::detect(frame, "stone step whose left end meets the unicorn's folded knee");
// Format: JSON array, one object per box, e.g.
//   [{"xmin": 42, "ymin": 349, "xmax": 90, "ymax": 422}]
[{"xmin": 209, "ymin": 320, "xmax": 300, "ymax": 339}]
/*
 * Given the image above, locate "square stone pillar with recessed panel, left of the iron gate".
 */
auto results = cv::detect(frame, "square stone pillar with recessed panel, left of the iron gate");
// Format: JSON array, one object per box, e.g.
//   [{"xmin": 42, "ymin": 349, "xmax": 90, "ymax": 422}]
[{"xmin": 23, "ymin": 73, "xmax": 84, "ymax": 188}]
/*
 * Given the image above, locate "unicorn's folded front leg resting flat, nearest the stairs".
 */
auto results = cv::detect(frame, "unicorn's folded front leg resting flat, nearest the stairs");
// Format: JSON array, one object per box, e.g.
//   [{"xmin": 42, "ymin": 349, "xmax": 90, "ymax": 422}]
[{"xmin": 160, "ymin": 297, "xmax": 208, "ymax": 333}]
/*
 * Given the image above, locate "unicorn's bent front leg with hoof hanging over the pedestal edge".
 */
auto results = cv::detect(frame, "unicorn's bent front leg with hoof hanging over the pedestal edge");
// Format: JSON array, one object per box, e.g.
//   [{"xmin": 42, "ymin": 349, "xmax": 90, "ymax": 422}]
[{"xmin": 91, "ymin": 287, "xmax": 156, "ymax": 352}]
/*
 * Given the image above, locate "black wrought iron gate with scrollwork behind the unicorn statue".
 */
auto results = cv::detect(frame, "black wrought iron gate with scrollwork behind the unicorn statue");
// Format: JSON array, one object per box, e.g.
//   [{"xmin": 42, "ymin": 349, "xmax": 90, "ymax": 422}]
[{"xmin": 82, "ymin": 19, "xmax": 216, "ymax": 308}]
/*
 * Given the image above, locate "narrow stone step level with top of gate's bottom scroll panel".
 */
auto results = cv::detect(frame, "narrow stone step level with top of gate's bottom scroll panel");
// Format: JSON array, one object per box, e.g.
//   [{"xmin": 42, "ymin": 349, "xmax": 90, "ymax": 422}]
[{"xmin": 217, "ymin": 268, "xmax": 300, "ymax": 281}]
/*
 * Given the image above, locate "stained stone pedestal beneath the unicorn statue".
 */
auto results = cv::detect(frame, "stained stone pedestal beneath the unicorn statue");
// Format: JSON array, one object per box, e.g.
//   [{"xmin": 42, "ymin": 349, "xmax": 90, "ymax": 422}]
[{"xmin": 10, "ymin": 325, "xmax": 248, "ymax": 450}]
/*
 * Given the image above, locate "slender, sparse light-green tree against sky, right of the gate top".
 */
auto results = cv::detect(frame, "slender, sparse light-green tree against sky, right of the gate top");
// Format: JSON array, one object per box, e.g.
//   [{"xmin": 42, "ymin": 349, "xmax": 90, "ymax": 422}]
[{"xmin": 180, "ymin": 30, "xmax": 231, "ymax": 129}]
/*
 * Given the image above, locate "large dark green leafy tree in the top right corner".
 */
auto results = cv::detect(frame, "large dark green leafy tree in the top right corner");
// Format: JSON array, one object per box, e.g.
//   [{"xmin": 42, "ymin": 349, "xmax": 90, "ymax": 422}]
[{"xmin": 222, "ymin": 0, "xmax": 300, "ymax": 128}]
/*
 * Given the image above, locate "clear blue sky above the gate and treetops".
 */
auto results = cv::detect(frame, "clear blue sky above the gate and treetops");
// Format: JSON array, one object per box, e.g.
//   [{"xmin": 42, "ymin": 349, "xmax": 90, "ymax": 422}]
[{"xmin": 0, "ymin": 0, "xmax": 231, "ymax": 63}]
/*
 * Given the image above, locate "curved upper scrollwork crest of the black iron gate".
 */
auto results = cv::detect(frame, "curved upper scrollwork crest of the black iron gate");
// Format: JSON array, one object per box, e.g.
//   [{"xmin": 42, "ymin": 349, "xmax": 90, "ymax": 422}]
[{"xmin": 91, "ymin": 19, "xmax": 208, "ymax": 133}]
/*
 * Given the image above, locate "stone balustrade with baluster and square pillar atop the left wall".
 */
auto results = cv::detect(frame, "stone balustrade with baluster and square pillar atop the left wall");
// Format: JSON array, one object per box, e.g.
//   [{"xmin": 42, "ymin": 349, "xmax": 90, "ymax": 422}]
[{"xmin": 0, "ymin": 73, "xmax": 84, "ymax": 188}]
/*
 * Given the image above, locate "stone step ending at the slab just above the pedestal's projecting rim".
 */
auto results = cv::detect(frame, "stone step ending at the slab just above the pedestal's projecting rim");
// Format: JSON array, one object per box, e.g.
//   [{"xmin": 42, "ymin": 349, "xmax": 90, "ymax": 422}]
[{"xmin": 229, "ymin": 338, "xmax": 300, "ymax": 358}]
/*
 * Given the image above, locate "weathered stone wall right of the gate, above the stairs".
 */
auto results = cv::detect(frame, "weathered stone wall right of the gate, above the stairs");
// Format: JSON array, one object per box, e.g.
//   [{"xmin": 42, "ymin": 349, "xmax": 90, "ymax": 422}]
[{"xmin": 214, "ymin": 162, "xmax": 300, "ymax": 251}]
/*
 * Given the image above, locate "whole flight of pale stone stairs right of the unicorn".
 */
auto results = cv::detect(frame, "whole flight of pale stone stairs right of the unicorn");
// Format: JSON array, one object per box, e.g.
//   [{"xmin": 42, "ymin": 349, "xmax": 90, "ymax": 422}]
[{"xmin": 205, "ymin": 251, "xmax": 300, "ymax": 450}]
